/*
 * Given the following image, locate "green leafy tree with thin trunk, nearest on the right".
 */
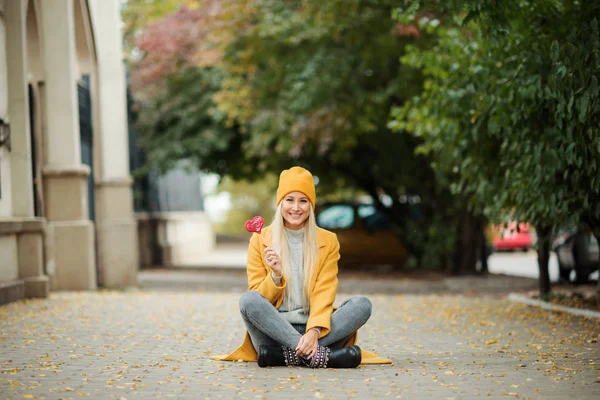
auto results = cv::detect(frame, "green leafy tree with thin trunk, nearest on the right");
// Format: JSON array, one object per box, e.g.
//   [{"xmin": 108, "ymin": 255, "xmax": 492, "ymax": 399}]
[{"xmin": 391, "ymin": 1, "xmax": 600, "ymax": 294}]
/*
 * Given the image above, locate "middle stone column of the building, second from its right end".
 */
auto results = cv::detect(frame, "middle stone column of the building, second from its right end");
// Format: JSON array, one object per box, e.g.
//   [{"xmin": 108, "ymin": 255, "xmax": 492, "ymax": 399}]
[{"xmin": 40, "ymin": 0, "xmax": 96, "ymax": 290}]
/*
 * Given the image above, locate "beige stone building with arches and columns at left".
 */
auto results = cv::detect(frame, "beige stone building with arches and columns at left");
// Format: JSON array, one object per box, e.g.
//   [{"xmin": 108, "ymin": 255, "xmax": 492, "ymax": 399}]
[{"xmin": 0, "ymin": 0, "xmax": 139, "ymax": 304}]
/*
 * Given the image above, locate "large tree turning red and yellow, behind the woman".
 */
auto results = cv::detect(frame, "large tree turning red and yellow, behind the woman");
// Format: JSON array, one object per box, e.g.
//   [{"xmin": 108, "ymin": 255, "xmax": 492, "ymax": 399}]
[{"xmin": 132, "ymin": 0, "xmax": 464, "ymax": 265}]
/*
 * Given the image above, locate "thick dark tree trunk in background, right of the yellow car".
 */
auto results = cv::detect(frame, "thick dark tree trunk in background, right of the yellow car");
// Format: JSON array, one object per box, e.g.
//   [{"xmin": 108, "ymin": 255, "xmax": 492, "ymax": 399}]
[{"xmin": 450, "ymin": 210, "xmax": 484, "ymax": 275}]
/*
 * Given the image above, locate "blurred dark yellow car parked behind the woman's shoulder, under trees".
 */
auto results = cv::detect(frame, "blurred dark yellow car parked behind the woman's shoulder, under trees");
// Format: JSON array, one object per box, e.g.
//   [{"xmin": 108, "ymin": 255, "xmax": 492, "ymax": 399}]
[{"xmin": 316, "ymin": 203, "xmax": 409, "ymax": 267}]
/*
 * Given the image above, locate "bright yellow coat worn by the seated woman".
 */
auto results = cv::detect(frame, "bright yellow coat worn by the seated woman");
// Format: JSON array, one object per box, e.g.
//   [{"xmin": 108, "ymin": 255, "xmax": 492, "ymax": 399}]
[{"xmin": 211, "ymin": 227, "xmax": 392, "ymax": 364}]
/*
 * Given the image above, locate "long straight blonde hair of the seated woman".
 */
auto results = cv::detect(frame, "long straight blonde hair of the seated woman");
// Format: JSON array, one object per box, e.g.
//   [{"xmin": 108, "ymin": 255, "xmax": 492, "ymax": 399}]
[{"xmin": 271, "ymin": 203, "xmax": 319, "ymax": 308}]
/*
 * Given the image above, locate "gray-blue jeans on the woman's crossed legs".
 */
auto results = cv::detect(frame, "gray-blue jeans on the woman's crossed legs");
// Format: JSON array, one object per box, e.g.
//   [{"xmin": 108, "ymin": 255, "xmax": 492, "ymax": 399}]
[{"xmin": 240, "ymin": 290, "xmax": 372, "ymax": 351}]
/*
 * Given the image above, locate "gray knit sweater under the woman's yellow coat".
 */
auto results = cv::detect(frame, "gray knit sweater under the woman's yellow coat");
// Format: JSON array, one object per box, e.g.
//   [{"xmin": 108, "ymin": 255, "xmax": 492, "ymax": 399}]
[{"xmin": 273, "ymin": 228, "xmax": 310, "ymax": 324}]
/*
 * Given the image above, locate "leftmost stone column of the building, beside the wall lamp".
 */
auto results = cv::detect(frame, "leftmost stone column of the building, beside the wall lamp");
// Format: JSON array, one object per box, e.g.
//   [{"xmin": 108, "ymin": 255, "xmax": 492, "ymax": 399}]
[{"xmin": 0, "ymin": 0, "xmax": 49, "ymax": 297}]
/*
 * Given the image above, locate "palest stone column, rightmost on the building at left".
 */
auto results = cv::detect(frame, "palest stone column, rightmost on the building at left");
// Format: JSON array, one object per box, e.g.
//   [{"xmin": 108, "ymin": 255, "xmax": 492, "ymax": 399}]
[{"xmin": 89, "ymin": 0, "xmax": 139, "ymax": 287}]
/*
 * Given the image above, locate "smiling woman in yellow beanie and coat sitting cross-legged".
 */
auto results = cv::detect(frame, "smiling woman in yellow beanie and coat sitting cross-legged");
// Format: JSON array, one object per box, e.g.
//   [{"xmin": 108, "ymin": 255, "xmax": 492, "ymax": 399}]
[{"xmin": 212, "ymin": 167, "xmax": 391, "ymax": 368}]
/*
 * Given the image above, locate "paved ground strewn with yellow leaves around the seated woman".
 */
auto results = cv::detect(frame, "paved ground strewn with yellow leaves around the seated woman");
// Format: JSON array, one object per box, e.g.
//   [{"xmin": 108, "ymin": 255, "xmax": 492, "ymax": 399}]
[{"xmin": 0, "ymin": 291, "xmax": 600, "ymax": 399}]
